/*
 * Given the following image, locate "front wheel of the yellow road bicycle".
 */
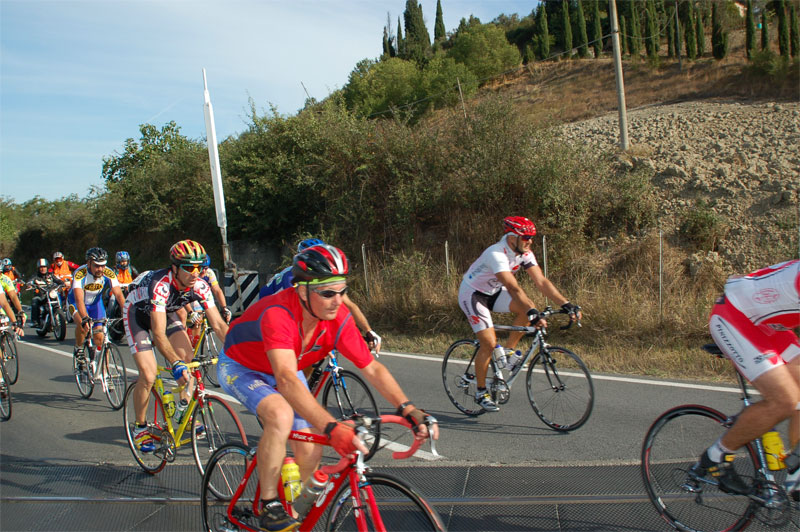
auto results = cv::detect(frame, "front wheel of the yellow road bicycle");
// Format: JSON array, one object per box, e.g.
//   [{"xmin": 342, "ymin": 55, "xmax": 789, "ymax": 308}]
[{"xmin": 191, "ymin": 395, "xmax": 247, "ymax": 494}]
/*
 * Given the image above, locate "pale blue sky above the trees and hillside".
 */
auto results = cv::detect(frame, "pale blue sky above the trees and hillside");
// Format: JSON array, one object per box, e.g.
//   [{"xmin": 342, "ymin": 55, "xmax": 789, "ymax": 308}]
[{"xmin": 0, "ymin": 0, "xmax": 536, "ymax": 203}]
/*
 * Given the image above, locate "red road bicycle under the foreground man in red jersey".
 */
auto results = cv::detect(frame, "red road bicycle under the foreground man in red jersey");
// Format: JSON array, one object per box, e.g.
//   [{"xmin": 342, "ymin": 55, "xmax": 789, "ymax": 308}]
[{"xmin": 200, "ymin": 415, "xmax": 445, "ymax": 532}]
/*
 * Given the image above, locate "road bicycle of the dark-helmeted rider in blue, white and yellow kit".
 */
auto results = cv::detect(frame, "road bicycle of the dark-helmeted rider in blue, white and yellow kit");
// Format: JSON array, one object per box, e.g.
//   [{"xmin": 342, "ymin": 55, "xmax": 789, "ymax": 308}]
[{"xmin": 72, "ymin": 318, "xmax": 128, "ymax": 410}]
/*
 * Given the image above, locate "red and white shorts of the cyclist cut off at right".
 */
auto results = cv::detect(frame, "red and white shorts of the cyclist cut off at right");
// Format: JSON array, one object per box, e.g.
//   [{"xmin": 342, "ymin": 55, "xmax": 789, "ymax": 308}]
[{"xmin": 708, "ymin": 298, "xmax": 800, "ymax": 382}]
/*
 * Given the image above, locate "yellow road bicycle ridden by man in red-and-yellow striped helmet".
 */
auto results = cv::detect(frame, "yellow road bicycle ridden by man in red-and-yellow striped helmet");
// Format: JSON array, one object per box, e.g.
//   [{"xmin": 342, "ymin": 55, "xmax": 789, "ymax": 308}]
[{"xmin": 123, "ymin": 358, "xmax": 247, "ymax": 475}]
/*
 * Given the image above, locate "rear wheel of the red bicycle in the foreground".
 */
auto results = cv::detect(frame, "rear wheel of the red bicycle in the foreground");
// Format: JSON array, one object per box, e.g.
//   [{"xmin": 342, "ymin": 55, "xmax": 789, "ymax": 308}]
[{"xmin": 200, "ymin": 443, "xmax": 253, "ymax": 532}]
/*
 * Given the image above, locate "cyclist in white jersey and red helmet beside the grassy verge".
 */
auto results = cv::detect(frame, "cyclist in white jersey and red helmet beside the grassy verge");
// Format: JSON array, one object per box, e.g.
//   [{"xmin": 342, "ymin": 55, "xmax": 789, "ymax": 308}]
[{"xmin": 458, "ymin": 216, "xmax": 581, "ymax": 412}]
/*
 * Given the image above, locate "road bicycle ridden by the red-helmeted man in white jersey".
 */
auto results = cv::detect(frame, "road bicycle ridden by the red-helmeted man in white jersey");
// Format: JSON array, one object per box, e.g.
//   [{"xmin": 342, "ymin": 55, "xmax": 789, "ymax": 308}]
[{"xmin": 442, "ymin": 307, "xmax": 594, "ymax": 432}]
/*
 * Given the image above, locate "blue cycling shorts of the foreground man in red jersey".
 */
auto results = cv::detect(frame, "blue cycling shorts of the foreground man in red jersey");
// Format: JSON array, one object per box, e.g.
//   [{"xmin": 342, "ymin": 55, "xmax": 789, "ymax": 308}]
[{"xmin": 217, "ymin": 351, "xmax": 312, "ymax": 430}]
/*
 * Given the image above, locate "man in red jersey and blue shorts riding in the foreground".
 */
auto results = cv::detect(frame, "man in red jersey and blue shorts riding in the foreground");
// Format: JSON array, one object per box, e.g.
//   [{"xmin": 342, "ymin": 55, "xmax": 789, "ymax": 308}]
[{"xmin": 217, "ymin": 244, "xmax": 438, "ymax": 532}]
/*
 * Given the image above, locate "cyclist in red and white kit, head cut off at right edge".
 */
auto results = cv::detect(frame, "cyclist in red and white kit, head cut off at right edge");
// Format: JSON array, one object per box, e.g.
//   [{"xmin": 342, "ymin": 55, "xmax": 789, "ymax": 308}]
[{"xmin": 695, "ymin": 260, "xmax": 800, "ymax": 499}]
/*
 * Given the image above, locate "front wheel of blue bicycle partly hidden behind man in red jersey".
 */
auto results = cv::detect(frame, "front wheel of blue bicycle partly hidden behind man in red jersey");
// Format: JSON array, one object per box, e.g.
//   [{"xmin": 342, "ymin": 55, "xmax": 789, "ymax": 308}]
[{"xmin": 322, "ymin": 369, "xmax": 381, "ymax": 460}]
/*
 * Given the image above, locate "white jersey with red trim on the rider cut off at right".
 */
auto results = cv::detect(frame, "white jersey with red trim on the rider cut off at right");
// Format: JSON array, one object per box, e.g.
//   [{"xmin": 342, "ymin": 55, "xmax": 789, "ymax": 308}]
[{"xmin": 725, "ymin": 260, "xmax": 800, "ymax": 327}]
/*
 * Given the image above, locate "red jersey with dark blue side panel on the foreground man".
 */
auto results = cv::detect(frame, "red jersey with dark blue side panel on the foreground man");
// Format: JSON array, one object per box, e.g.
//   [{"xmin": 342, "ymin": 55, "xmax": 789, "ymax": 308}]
[{"xmin": 224, "ymin": 288, "xmax": 373, "ymax": 374}]
